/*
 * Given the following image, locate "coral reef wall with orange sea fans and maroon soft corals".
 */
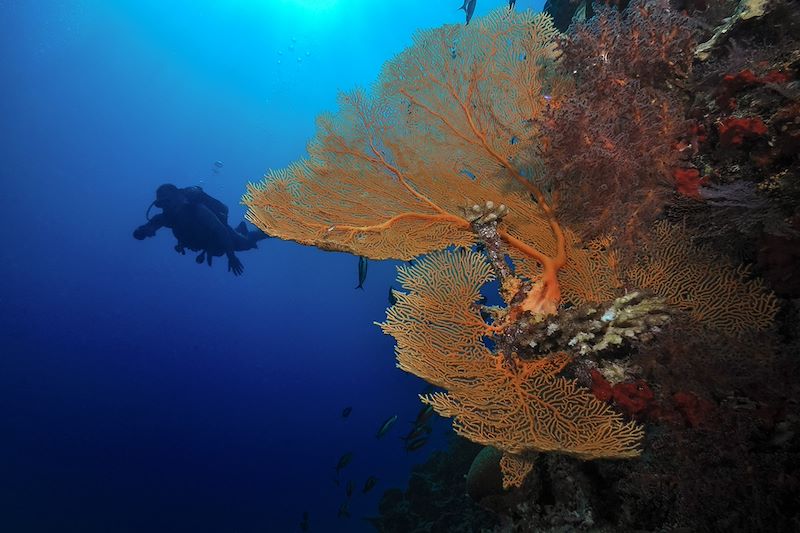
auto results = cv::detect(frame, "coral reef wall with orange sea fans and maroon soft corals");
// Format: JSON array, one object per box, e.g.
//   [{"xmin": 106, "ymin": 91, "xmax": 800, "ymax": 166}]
[{"xmin": 244, "ymin": 0, "xmax": 800, "ymax": 531}]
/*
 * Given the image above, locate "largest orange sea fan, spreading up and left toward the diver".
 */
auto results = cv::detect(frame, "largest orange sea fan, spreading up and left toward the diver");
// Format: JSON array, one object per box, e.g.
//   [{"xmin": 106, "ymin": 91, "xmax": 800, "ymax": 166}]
[{"xmin": 244, "ymin": 9, "xmax": 592, "ymax": 309}]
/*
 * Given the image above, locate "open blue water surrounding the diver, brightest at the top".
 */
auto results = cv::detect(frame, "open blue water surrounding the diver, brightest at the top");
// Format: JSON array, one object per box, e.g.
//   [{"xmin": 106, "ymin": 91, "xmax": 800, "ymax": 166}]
[{"xmin": 0, "ymin": 0, "xmax": 541, "ymax": 533}]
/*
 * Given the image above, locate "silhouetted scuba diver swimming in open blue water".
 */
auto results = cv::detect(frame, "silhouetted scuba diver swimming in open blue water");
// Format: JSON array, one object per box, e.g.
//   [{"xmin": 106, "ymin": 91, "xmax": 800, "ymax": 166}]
[{"xmin": 133, "ymin": 183, "xmax": 268, "ymax": 276}]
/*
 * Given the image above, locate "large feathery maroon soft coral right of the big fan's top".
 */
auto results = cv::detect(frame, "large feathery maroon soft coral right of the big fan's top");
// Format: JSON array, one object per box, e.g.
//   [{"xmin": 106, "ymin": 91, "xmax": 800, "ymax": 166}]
[{"xmin": 541, "ymin": 1, "xmax": 695, "ymax": 248}]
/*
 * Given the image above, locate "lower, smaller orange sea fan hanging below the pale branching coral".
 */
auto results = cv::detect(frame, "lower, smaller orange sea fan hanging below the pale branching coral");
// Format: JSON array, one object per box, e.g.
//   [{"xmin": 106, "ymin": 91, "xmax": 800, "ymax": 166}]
[{"xmin": 380, "ymin": 250, "xmax": 643, "ymax": 484}]
